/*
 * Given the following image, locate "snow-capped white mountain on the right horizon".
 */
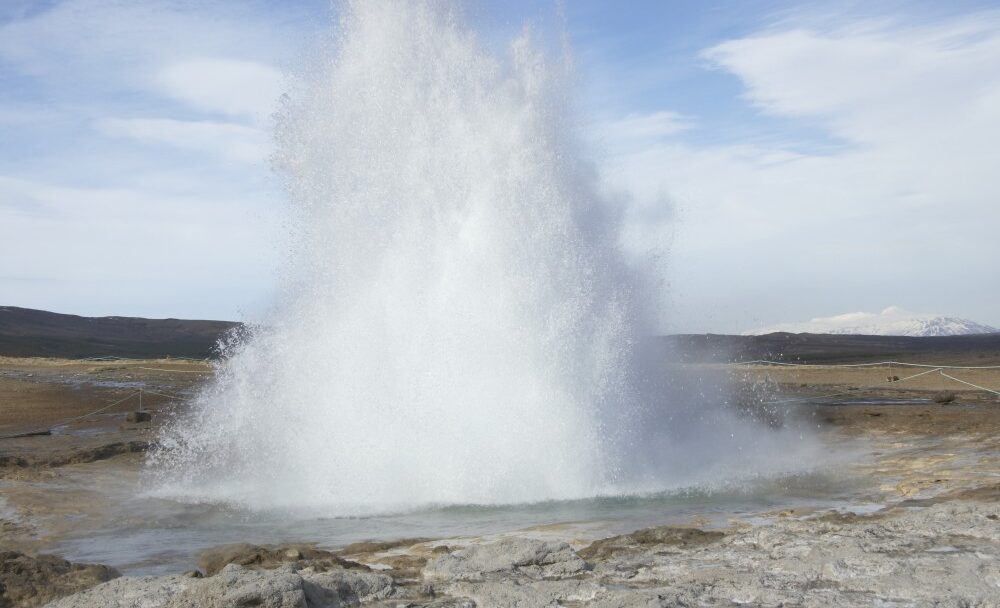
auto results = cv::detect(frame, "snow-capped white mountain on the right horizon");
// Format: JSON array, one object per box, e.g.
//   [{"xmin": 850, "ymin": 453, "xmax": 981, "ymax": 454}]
[{"xmin": 743, "ymin": 306, "xmax": 1000, "ymax": 336}]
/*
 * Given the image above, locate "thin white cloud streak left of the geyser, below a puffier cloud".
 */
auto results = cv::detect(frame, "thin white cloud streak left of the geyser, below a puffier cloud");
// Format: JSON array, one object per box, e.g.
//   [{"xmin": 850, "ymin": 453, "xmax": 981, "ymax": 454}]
[{"xmin": 96, "ymin": 118, "xmax": 271, "ymax": 163}]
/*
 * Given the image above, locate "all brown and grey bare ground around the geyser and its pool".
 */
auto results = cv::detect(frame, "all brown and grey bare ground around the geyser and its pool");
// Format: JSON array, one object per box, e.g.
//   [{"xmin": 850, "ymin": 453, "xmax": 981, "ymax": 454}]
[{"xmin": 0, "ymin": 360, "xmax": 1000, "ymax": 607}]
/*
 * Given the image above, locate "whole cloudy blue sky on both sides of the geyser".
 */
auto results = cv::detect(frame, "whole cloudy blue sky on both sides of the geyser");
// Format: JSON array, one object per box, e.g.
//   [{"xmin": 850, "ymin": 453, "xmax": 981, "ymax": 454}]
[{"xmin": 0, "ymin": 0, "xmax": 1000, "ymax": 333}]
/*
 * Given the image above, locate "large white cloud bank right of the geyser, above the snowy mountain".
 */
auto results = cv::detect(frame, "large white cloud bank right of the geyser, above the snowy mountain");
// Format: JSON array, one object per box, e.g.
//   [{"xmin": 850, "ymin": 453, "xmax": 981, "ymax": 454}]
[{"xmin": 596, "ymin": 13, "xmax": 1000, "ymax": 330}]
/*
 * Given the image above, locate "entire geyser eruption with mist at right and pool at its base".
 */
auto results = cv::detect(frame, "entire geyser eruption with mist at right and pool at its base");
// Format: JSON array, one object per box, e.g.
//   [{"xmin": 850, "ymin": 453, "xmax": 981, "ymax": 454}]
[{"xmin": 31, "ymin": 2, "xmax": 855, "ymax": 572}]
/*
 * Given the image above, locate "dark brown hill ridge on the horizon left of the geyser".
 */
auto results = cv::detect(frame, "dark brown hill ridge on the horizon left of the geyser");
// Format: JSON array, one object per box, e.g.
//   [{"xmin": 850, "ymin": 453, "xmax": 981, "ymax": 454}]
[{"xmin": 0, "ymin": 306, "xmax": 238, "ymax": 359}]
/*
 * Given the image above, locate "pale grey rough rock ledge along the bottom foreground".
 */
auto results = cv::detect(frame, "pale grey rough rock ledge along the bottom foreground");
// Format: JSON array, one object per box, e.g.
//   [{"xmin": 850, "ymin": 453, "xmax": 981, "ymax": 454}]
[{"xmin": 41, "ymin": 488, "xmax": 1000, "ymax": 608}]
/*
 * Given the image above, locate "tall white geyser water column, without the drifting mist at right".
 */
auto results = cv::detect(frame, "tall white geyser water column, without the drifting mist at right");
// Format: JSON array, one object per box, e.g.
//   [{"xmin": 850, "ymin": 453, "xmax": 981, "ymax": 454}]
[{"xmin": 152, "ymin": 1, "xmax": 640, "ymax": 514}]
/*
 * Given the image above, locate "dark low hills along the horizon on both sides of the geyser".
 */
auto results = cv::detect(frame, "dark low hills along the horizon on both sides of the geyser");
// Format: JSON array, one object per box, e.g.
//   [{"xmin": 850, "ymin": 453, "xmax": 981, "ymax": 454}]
[{"xmin": 0, "ymin": 306, "xmax": 1000, "ymax": 365}]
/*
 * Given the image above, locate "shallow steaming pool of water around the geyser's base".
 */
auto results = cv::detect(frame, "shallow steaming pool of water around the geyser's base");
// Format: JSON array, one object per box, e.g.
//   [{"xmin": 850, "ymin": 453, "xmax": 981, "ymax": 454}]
[{"xmin": 53, "ymin": 460, "xmax": 881, "ymax": 575}]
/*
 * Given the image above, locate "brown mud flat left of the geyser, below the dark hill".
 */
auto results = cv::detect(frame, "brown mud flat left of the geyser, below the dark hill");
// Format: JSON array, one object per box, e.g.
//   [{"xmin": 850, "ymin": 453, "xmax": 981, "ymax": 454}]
[{"xmin": 0, "ymin": 357, "xmax": 212, "ymax": 560}]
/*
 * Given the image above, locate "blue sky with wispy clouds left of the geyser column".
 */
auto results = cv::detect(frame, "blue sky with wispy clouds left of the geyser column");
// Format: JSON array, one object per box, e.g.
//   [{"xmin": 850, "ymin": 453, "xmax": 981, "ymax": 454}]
[{"xmin": 0, "ymin": 0, "xmax": 306, "ymax": 317}]
